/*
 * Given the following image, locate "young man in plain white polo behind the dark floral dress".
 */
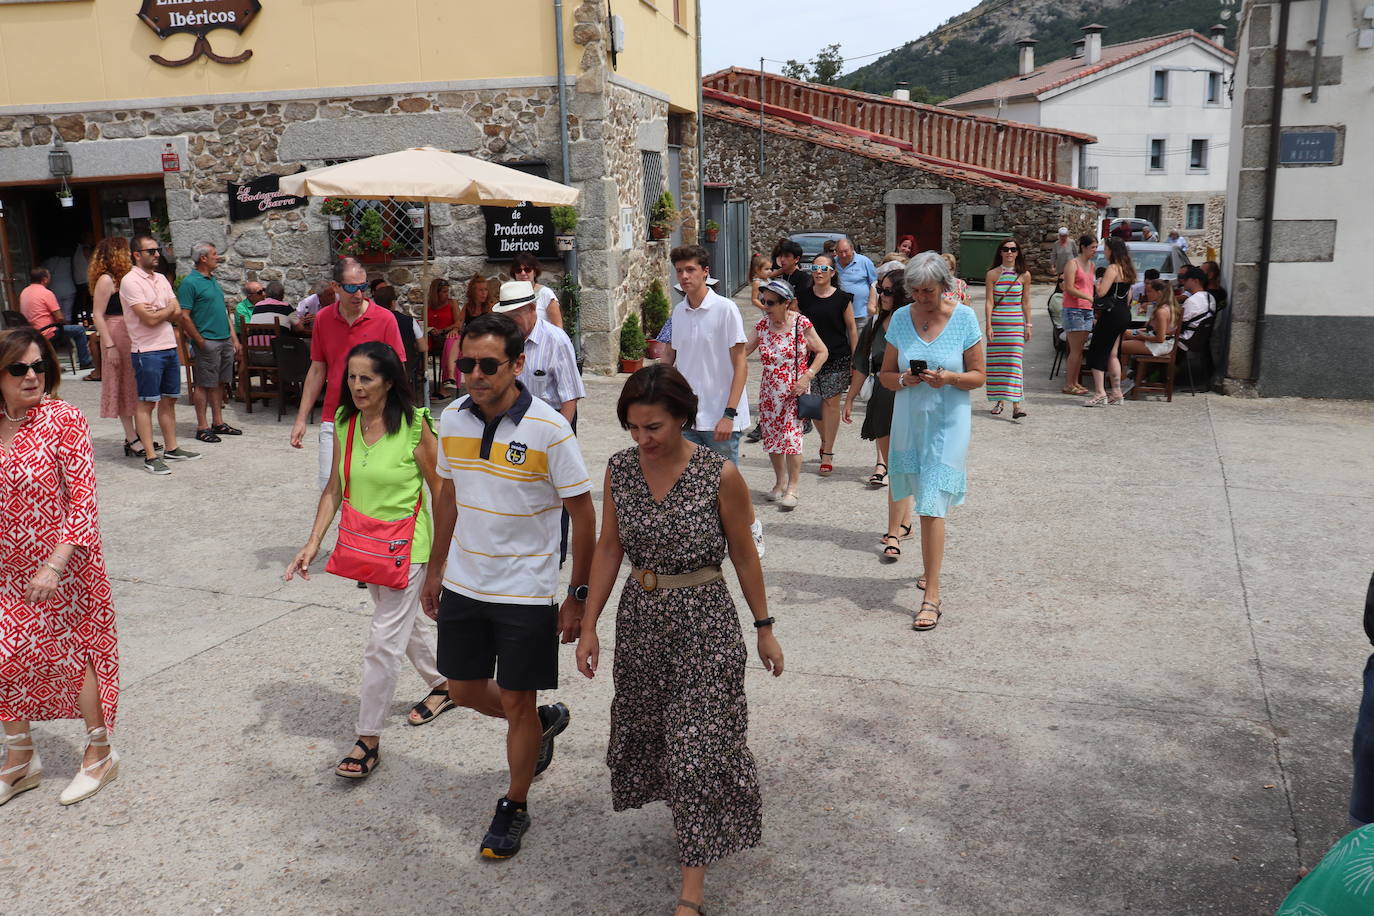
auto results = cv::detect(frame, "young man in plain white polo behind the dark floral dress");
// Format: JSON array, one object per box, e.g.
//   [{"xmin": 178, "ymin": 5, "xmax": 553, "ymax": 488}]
[{"xmin": 664, "ymin": 244, "xmax": 764, "ymax": 559}]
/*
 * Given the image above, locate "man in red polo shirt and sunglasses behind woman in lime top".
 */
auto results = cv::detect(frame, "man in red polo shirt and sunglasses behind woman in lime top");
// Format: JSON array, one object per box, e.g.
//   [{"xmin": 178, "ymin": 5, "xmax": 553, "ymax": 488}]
[{"xmin": 291, "ymin": 258, "xmax": 405, "ymax": 490}]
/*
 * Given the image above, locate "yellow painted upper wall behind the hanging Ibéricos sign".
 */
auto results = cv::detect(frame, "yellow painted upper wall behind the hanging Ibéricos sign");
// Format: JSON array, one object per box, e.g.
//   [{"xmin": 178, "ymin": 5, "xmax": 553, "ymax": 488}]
[{"xmin": 0, "ymin": 0, "xmax": 695, "ymax": 110}]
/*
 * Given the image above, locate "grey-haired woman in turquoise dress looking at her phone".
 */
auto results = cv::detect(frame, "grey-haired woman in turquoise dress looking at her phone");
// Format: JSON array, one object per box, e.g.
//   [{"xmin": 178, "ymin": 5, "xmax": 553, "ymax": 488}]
[{"xmin": 878, "ymin": 251, "xmax": 987, "ymax": 630}]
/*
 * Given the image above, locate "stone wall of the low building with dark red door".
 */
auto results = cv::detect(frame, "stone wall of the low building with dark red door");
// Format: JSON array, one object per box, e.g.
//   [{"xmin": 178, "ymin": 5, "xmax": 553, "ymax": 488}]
[{"xmin": 705, "ymin": 119, "xmax": 1096, "ymax": 277}]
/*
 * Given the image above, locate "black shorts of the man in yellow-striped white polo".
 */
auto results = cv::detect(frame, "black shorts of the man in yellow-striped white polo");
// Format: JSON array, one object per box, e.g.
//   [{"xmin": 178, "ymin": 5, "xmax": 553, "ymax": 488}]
[{"xmin": 437, "ymin": 588, "xmax": 558, "ymax": 691}]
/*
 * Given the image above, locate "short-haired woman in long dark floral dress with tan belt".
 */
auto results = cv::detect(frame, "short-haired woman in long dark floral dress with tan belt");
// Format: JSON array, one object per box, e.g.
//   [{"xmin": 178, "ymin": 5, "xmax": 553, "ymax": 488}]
[{"xmin": 577, "ymin": 365, "xmax": 783, "ymax": 916}]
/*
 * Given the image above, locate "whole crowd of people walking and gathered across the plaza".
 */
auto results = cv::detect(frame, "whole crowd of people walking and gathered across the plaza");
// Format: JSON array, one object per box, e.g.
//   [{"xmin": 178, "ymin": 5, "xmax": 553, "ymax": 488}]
[{"xmin": 0, "ymin": 223, "xmax": 1242, "ymax": 916}]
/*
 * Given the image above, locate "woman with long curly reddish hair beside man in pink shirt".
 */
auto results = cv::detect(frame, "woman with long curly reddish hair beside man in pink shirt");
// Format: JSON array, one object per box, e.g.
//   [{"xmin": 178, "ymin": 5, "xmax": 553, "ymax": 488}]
[{"xmin": 87, "ymin": 236, "xmax": 147, "ymax": 457}]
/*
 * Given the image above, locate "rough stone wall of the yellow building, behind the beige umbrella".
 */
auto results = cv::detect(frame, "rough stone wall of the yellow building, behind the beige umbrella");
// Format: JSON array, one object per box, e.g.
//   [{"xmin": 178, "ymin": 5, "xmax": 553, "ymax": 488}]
[{"xmin": 0, "ymin": 73, "xmax": 695, "ymax": 368}]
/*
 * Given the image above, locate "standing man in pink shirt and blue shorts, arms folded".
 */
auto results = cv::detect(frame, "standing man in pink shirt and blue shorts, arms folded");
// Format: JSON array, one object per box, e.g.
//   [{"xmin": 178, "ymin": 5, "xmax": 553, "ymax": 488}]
[{"xmin": 120, "ymin": 235, "xmax": 201, "ymax": 475}]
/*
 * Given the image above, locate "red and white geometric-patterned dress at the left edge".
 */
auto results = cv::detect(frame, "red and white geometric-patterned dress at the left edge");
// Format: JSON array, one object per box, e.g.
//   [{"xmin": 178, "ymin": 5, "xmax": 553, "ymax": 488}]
[{"xmin": 0, "ymin": 400, "xmax": 120, "ymax": 731}]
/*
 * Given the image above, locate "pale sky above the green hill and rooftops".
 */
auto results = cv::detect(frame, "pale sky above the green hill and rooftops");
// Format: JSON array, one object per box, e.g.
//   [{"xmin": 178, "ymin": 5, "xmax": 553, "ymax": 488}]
[{"xmin": 701, "ymin": 0, "xmax": 978, "ymax": 73}]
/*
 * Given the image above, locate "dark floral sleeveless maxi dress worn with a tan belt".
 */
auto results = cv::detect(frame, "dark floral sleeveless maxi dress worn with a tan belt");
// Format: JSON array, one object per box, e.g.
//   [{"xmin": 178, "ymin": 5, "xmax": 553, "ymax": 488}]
[{"xmin": 606, "ymin": 446, "xmax": 763, "ymax": 867}]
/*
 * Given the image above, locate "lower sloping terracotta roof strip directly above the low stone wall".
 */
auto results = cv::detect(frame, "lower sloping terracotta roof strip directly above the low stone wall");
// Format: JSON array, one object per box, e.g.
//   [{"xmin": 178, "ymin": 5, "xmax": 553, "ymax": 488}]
[{"xmin": 702, "ymin": 89, "xmax": 1107, "ymax": 207}]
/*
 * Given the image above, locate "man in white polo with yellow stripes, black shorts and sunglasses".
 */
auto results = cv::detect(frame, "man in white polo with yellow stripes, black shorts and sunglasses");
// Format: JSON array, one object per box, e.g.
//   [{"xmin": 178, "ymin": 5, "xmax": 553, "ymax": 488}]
[{"xmin": 422, "ymin": 314, "xmax": 596, "ymax": 858}]
